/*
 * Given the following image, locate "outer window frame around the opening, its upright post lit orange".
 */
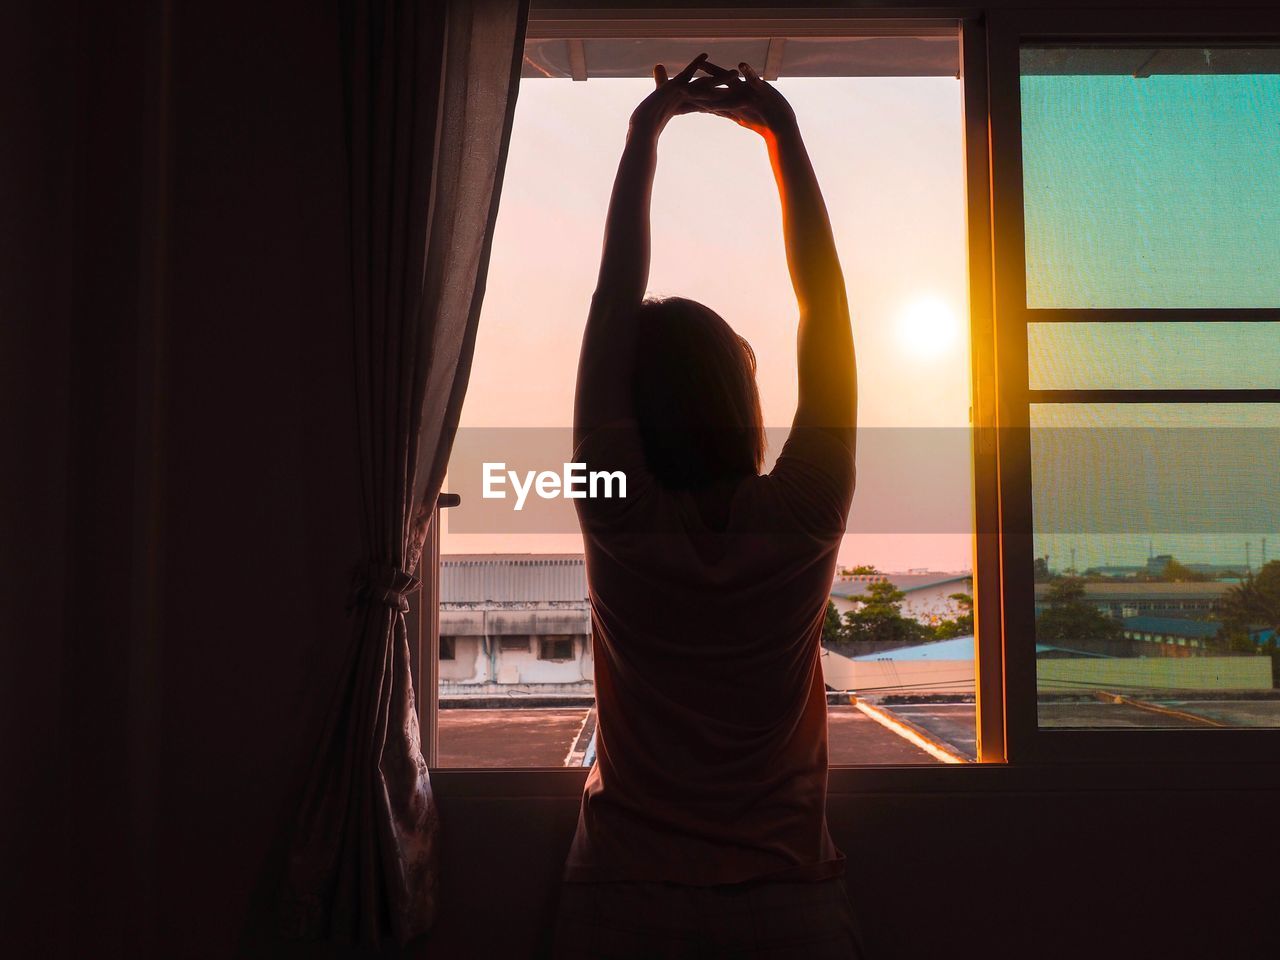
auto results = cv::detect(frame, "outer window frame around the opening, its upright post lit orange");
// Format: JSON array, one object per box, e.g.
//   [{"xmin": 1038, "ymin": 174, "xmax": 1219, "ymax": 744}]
[{"xmin": 410, "ymin": 0, "xmax": 1280, "ymax": 797}]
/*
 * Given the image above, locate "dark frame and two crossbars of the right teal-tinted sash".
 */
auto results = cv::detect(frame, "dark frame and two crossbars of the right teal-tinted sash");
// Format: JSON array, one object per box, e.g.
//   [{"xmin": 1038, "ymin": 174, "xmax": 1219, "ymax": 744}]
[{"xmin": 987, "ymin": 6, "xmax": 1280, "ymax": 764}]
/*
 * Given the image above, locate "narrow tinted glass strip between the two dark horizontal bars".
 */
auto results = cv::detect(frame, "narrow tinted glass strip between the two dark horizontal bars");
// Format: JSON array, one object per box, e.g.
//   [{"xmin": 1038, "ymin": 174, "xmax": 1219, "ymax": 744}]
[{"xmin": 1027, "ymin": 321, "xmax": 1280, "ymax": 390}]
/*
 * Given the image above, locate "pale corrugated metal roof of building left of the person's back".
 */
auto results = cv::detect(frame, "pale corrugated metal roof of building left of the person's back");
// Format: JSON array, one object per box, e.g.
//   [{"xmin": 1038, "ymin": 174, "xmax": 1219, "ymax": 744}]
[{"xmin": 440, "ymin": 553, "xmax": 588, "ymax": 603}]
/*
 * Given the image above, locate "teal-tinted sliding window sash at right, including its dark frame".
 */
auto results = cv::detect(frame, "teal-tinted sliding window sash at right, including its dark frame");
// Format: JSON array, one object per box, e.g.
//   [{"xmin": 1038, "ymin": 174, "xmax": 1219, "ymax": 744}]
[{"xmin": 992, "ymin": 14, "xmax": 1280, "ymax": 759}]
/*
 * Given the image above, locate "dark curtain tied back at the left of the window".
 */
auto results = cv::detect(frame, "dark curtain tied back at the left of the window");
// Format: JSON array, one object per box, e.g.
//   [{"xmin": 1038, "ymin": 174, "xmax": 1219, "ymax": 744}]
[{"xmin": 283, "ymin": 0, "xmax": 527, "ymax": 943}]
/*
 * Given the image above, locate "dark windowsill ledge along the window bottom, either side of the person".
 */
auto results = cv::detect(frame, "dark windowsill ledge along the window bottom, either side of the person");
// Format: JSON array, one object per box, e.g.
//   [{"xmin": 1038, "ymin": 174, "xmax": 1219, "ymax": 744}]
[{"xmin": 431, "ymin": 760, "xmax": 1280, "ymax": 799}]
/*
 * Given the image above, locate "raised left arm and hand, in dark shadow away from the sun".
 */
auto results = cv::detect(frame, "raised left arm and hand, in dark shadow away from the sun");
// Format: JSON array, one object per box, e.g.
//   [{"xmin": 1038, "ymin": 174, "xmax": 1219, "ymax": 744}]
[{"xmin": 573, "ymin": 54, "xmax": 714, "ymax": 445}]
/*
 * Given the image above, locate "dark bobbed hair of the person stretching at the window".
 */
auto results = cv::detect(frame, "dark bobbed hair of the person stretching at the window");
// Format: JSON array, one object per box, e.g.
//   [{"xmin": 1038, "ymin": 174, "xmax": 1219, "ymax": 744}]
[{"xmin": 634, "ymin": 297, "xmax": 764, "ymax": 489}]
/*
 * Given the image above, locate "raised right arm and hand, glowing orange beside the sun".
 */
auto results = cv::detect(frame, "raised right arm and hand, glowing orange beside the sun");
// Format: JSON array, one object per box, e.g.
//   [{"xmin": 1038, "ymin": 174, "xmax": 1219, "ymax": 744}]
[{"xmin": 701, "ymin": 63, "xmax": 858, "ymax": 448}]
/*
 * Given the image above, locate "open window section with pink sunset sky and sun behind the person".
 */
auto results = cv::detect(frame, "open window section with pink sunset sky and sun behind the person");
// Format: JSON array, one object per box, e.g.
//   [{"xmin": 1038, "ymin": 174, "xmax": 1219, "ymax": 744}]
[{"xmin": 438, "ymin": 18, "xmax": 978, "ymax": 765}]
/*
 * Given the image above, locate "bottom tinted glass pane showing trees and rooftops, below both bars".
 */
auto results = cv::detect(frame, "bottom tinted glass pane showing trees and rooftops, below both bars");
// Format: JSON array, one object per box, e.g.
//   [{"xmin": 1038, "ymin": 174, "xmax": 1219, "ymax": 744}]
[{"xmin": 1030, "ymin": 403, "xmax": 1280, "ymax": 727}]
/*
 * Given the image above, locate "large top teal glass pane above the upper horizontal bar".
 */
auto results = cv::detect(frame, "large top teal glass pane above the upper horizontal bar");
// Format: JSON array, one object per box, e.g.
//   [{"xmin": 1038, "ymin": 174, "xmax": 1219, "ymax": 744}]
[{"xmin": 1021, "ymin": 47, "xmax": 1280, "ymax": 307}]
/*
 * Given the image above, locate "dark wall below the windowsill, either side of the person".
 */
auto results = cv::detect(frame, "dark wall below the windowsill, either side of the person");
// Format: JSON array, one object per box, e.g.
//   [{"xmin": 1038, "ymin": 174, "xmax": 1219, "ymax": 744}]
[{"xmin": 419, "ymin": 783, "xmax": 1280, "ymax": 960}]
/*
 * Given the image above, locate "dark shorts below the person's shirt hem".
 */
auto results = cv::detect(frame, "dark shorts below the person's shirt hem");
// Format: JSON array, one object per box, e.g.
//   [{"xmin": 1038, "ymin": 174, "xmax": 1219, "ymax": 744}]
[{"xmin": 552, "ymin": 877, "xmax": 865, "ymax": 960}]
